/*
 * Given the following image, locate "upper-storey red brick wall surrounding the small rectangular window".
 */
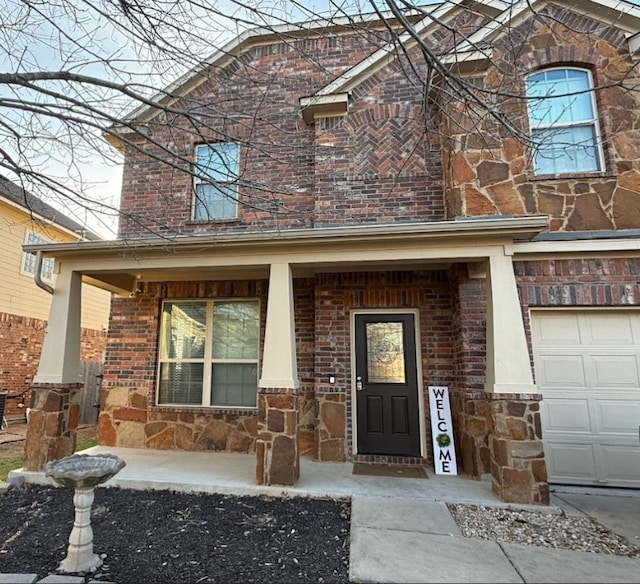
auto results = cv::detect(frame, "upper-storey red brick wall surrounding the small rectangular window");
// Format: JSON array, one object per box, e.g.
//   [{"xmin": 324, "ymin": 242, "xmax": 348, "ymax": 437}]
[{"xmin": 120, "ymin": 34, "xmax": 384, "ymax": 237}]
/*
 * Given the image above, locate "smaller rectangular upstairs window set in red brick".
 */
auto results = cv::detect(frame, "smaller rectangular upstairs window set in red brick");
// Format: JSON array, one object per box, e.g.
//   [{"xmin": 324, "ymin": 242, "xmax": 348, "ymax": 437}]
[{"xmin": 193, "ymin": 142, "xmax": 238, "ymax": 221}]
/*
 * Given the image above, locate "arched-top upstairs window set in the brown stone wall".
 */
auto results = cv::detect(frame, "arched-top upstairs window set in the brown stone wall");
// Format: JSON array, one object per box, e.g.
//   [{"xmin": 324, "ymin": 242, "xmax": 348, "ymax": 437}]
[{"xmin": 527, "ymin": 69, "xmax": 603, "ymax": 175}]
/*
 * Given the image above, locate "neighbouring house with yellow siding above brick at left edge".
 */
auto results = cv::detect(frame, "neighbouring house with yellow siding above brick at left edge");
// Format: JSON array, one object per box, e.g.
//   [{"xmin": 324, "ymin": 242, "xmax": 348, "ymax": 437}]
[{"xmin": 0, "ymin": 176, "xmax": 111, "ymax": 418}]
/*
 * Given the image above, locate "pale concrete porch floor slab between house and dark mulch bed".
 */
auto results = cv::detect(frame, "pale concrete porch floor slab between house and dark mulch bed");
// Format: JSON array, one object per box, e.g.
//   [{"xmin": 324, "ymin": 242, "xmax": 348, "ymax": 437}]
[{"xmin": 8, "ymin": 446, "xmax": 504, "ymax": 505}]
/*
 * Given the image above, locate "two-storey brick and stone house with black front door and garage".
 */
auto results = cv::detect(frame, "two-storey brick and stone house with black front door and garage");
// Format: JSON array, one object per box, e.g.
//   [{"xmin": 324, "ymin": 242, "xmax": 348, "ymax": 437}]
[{"xmin": 26, "ymin": 0, "xmax": 640, "ymax": 503}]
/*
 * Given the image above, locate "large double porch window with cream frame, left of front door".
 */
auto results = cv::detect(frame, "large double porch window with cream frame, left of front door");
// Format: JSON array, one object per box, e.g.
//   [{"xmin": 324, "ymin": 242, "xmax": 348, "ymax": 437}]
[{"xmin": 157, "ymin": 300, "xmax": 260, "ymax": 408}]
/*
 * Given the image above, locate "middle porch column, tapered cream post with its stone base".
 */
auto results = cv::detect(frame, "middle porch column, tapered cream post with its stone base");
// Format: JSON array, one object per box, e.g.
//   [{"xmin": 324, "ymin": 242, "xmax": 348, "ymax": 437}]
[{"xmin": 256, "ymin": 263, "xmax": 300, "ymax": 485}]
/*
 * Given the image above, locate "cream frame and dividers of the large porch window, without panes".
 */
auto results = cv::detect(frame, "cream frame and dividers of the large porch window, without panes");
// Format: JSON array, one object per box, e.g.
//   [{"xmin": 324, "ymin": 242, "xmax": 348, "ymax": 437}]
[{"xmin": 155, "ymin": 298, "xmax": 260, "ymax": 410}]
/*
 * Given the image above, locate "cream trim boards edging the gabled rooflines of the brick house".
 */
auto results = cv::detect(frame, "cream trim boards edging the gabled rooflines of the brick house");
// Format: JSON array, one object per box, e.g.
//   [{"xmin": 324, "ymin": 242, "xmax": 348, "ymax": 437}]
[{"xmin": 105, "ymin": 0, "xmax": 640, "ymax": 137}]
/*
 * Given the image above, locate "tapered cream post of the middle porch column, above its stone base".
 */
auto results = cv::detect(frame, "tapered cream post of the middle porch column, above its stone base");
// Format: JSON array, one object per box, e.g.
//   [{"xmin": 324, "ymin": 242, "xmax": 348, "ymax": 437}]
[{"xmin": 258, "ymin": 264, "xmax": 300, "ymax": 389}]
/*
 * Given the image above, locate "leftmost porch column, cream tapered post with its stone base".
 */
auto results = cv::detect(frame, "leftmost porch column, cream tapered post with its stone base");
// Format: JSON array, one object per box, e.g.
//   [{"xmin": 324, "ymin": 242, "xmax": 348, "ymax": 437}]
[{"xmin": 24, "ymin": 264, "xmax": 82, "ymax": 470}]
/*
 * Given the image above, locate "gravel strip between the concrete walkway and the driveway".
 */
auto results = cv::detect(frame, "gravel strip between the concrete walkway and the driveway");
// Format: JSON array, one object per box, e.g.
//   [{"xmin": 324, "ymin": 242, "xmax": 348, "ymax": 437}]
[{"xmin": 447, "ymin": 504, "xmax": 640, "ymax": 558}]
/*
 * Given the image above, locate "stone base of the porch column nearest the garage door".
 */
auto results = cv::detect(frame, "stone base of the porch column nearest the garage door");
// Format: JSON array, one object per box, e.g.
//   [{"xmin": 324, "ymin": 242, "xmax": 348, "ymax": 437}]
[{"xmin": 487, "ymin": 393, "xmax": 549, "ymax": 505}]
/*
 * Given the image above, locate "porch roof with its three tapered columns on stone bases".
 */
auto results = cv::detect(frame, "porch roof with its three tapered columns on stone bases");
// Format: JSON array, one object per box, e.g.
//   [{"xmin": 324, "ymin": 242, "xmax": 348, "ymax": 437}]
[{"xmin": 25, "ymin": 217, "xmax": 546, "ymax": 503}]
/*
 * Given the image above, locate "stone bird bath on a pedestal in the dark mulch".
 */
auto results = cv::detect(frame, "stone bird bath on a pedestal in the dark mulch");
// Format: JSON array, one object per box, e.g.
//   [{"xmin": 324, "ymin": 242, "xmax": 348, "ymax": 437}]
[{"xmin": 45, "ymin": 454, "xmax": 126, "ymax": 574}]
